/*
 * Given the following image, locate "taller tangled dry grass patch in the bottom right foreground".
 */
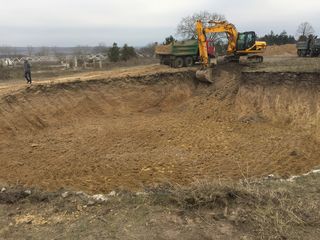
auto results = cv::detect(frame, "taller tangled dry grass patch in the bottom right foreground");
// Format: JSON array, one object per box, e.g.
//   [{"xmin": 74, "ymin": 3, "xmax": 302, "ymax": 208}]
[{"xmin": 148, "ymin": 176, "xmax": 320, "ymax": 239}]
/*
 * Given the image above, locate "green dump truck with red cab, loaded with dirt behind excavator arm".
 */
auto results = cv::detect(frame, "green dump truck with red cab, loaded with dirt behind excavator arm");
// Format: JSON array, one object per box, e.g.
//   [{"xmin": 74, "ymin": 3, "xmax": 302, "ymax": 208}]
[{"xmin": 155, "ymin": 39, "xmax": 215, "ymax": 68}]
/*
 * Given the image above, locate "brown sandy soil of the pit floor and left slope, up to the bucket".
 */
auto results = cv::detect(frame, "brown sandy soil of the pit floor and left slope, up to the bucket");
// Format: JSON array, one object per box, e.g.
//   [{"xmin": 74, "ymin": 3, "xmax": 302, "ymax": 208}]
[{"xmin": 0, "ymin": 62, "xmax": 320, "ymax": 192}]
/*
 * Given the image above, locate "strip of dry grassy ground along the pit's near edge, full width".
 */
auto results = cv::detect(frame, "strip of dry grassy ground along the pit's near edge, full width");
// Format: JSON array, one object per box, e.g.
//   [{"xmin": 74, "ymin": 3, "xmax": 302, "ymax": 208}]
[{"xmin": 0, "ymin": 174, "xmax": 320, "ymax": 240}]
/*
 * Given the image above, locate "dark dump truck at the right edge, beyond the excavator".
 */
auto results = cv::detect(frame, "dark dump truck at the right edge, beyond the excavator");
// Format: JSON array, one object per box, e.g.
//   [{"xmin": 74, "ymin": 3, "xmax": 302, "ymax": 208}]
[{"xmin": 297, "ymin": 37, "xmax": 320, "ymax": 57}]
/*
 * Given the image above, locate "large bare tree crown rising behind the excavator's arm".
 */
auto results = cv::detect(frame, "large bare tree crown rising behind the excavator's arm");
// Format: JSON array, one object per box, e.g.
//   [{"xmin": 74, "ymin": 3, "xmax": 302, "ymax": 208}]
[{"xmin": 177, "ymin": 11, "xmax": 225, "ymax": 38}]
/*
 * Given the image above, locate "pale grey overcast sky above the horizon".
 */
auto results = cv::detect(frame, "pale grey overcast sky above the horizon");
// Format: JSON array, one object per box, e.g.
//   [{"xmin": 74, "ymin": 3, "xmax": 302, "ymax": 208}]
[{"xmin": 0, "ymin": 0, "xmax": 320, "ymax": 46}]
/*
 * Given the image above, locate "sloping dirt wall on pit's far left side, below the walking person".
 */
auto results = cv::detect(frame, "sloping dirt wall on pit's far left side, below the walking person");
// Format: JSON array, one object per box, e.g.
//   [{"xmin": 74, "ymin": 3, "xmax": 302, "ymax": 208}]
[{"xmin": 0, "ymin": 72, "xmax": 195, "ymax": 134}]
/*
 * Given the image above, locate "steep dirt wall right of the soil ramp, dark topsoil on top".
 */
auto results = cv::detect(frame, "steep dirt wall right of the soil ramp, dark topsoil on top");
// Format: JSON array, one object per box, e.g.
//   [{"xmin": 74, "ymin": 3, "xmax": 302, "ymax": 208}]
[{"xmin": 236, "ymin": 72, "xmax": 320, "ymax": 139}]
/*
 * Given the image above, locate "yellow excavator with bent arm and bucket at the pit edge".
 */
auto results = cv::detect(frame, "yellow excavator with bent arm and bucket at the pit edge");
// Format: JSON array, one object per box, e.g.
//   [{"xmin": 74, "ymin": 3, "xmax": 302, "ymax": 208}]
[{"xmin": 196, "ymin": 20, "xmax": 267, "ymax": 82}]
